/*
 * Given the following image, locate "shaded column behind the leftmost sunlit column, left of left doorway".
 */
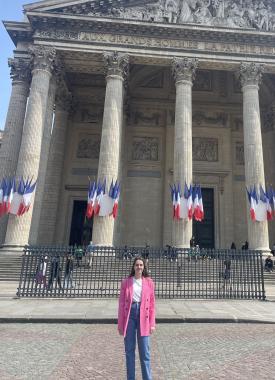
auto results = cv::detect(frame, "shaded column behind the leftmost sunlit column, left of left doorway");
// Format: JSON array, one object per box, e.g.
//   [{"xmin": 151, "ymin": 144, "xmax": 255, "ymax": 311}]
[{"xmin": 38, "ymin": 85, "xmax": 72, "ymax": 245}]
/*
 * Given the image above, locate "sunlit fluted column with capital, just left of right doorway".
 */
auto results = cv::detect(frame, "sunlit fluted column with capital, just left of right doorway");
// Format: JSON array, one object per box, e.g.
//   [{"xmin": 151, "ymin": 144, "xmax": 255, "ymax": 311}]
[{"xmin": 172, "ymin": 58, "xmax": 198, "ymax": 248}]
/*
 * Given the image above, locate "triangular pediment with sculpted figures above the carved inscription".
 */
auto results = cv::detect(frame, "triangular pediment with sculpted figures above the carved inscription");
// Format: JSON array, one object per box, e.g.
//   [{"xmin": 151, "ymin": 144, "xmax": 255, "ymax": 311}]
[{"xmin": 24, "ymin": 0, "xmax": 275, "ymax": 32}]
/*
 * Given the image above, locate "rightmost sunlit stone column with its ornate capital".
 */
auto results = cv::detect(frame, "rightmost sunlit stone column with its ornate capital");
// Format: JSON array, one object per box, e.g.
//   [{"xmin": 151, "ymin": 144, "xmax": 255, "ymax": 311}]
[{"xmin": 240, "ymin": 63, "xmax": 269, "ymax": 251}]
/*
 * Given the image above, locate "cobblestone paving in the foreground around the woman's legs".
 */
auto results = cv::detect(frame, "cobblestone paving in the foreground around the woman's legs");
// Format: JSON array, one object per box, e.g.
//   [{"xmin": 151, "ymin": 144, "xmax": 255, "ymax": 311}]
[{"xmin": 0, "ymin": 323, "xmax": 275, "ymax": 380}]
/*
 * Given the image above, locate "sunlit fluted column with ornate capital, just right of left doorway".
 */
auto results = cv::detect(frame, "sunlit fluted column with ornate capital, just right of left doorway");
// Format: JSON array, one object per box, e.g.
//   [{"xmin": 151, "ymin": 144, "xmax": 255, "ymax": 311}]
[{"xmin": 93, "ymin": 52, "xmax": 129, "ymax": 246}]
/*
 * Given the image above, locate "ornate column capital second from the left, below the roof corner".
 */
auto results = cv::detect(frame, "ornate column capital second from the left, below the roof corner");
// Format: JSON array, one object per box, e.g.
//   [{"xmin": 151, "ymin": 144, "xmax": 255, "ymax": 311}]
[{"xmin": 29, "ymin": 46, "xmax": 56, "ymax": 73}]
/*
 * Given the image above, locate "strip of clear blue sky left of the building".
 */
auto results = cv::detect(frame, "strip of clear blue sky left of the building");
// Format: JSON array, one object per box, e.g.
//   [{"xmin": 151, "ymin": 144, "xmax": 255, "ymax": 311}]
[{"xmin": 0, "ymin": 0, "xmax": 37, "ymax": 129}]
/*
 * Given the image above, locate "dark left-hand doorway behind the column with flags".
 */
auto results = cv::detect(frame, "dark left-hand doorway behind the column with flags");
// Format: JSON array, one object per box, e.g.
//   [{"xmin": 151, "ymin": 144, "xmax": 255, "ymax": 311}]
[{"xmin": 69, "ymin": 201, "xmax": 94, "ymax": 245}]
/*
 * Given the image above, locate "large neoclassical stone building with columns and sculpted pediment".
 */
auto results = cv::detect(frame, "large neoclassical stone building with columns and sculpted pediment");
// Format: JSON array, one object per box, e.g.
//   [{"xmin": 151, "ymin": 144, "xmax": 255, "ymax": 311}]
[{"xmin": 0, "ymin": 0, "xmax": 275, "ymax": 250}]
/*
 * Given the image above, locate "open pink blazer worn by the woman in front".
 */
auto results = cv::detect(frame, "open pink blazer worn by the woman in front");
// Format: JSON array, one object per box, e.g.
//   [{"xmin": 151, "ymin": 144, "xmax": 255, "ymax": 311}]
[{"xmin": 118, "ymin": 277, "xmax": 156, "ymax": 337}]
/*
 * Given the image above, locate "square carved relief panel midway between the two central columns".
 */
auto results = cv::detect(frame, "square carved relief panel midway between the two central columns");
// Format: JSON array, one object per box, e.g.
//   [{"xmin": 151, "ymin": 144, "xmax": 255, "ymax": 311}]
[{"xmin": 132, "ymin": 136, "xmax": 159, "ymax": 161}]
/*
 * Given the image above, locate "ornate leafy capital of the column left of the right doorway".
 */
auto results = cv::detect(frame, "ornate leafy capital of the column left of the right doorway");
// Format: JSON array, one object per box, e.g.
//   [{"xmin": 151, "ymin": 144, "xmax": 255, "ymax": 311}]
[{"xmin": 172, "ymin": 57, "xmax": 198, "ymax": 83}]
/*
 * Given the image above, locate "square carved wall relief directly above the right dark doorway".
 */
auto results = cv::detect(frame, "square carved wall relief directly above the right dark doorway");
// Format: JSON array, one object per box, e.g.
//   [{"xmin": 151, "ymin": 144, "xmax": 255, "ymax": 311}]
[{"xmin": 192, "ymin": 137, "xmax": 218, "ymax": 162}]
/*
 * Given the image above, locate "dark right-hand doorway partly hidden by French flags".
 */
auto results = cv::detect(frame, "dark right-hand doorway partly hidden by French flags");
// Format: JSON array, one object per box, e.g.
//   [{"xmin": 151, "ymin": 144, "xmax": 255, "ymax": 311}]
[{"xmin": 193, "ymin": 188, "xmax": 215, "ymax": 248}]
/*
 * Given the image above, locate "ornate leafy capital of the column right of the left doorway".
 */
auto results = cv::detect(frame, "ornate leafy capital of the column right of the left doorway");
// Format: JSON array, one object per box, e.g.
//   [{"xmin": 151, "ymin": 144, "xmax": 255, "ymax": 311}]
[{"xmin": 103, "ymin": 51, "xmax": 129, "ymax": 81}]
